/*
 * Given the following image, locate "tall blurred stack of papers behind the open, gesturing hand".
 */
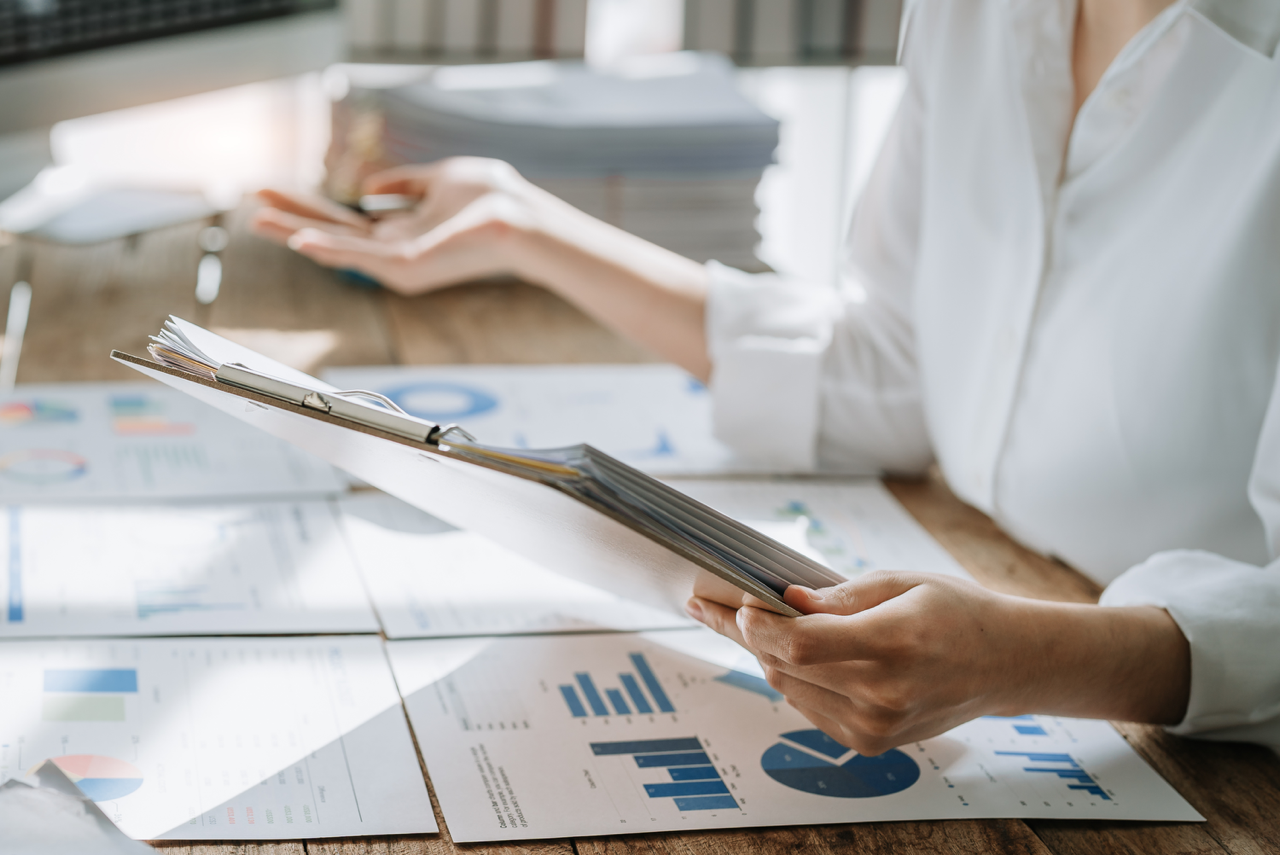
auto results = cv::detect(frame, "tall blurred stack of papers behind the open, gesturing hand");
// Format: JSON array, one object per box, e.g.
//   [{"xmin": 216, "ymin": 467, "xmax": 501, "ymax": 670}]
[{"xmin": 329, "ymin": 52, "xmax": 778, "ymax": 270}]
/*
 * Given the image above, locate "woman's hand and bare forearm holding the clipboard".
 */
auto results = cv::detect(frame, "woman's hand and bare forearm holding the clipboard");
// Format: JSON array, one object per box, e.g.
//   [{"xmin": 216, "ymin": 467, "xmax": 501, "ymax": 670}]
[{"xmin": 689, "ymin": 572, "xmax": 1190, "ymax": 755}]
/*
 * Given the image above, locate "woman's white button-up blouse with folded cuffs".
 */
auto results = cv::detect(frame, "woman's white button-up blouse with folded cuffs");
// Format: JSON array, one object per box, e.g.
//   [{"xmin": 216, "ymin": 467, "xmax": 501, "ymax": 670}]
[{"xmin": 708, "ymin": 0, "xmax": 1280, "ymax": 744}]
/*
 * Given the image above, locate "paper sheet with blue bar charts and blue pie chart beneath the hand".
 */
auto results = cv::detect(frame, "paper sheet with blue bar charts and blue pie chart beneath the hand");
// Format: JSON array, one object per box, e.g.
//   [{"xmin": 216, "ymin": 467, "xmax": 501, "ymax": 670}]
[{"xmin": 388, "ymin": 630, "xmax": 1202, "ymax": 842}]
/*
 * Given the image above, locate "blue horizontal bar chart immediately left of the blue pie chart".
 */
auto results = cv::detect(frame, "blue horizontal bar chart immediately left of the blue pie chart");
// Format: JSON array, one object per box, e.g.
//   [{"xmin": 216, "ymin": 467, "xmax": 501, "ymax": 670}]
[{"xmin": 591, "ymin": 736, "xmax": 739, "ymax": 813}]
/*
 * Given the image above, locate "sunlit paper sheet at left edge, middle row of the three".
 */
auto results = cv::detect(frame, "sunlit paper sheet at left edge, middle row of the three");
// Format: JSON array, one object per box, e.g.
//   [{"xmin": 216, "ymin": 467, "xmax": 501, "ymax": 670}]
[{"xmin": 0, "ymin": 502, "xmax": 379, "ymax": 636}]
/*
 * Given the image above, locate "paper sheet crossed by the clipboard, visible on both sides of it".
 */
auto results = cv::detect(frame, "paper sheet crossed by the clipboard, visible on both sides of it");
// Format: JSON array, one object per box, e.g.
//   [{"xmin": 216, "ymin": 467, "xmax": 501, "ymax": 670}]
[{"xmin": 340, "ymin": 480, "xmax": 965, "ymax": 639}]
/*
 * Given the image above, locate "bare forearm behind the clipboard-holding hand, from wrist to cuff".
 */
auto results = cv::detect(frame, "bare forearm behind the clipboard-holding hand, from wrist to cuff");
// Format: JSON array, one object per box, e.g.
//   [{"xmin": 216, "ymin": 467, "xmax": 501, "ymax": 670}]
[{"xmin": 998, "ymin": 600, "xmax": 1190, "ymax": 724}]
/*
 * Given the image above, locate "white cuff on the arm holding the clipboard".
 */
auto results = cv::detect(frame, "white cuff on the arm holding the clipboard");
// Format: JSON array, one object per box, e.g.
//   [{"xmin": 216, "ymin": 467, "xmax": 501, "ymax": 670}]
[{"xmin": 1101, "ymin": 550, "xmax": 1280, "ymax": 744}]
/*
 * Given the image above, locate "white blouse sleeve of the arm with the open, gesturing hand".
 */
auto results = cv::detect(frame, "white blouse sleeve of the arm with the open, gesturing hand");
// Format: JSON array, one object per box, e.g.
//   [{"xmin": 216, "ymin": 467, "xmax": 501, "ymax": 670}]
[{"xmin": 707, "ymin": 16, "xmax": 933, "ymax": 474}]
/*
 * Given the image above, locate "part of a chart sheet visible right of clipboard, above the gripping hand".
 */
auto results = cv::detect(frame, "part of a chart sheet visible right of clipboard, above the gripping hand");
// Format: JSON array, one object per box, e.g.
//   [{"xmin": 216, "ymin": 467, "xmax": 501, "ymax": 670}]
[{"xmin": 672, "ymin": 479, "xmax": 969, "ymax": 579}]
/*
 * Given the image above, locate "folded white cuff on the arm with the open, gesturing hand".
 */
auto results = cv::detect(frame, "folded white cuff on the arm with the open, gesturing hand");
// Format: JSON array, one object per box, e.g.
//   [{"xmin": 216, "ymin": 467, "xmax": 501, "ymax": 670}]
[{"xmin": 707, "ymin": 261, "xmax": 836, "ymax": 471}]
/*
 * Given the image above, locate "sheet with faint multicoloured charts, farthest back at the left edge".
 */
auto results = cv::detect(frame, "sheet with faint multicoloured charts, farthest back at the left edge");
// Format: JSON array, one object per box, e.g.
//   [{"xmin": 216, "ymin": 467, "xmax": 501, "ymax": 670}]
[{"xmin": 0, "ymin": 383, "xmax": 344, "ymax": 502}]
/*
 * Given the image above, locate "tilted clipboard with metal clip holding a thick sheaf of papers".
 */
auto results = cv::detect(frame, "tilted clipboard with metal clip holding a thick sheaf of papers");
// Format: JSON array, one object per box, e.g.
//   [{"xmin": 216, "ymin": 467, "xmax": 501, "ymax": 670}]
[{"xmin": 113, "ymin": 319, "xmax": 842, "ymax": 616}]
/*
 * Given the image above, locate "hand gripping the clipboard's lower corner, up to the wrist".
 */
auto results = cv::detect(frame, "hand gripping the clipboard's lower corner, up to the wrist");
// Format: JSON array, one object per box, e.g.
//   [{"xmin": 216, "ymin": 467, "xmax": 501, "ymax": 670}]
[{"xmin": 689, "ymin": 572, "xmax": 1034, "ymax": 755}]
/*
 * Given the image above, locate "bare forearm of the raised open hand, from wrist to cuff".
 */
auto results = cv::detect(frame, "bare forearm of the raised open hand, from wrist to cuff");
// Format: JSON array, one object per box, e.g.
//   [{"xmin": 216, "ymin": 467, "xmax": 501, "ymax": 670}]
[{"xmin": 513, "ymin": 188, "xmax": 712, "ymax": 383}]
